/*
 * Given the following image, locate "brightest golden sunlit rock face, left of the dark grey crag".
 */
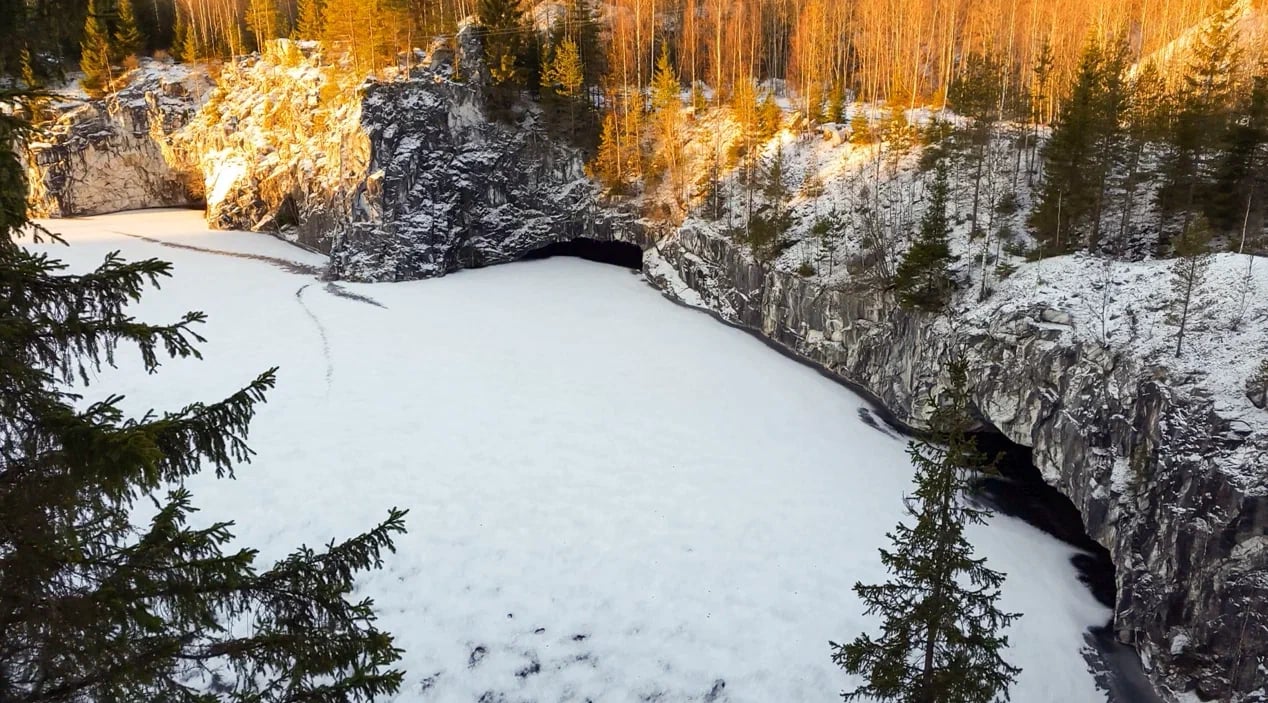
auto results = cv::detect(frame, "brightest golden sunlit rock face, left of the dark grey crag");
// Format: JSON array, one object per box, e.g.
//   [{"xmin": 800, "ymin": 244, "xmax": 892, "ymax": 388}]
[{"xmin": 168, "ymin": 39, "xmax": 368, "ymax": 250}]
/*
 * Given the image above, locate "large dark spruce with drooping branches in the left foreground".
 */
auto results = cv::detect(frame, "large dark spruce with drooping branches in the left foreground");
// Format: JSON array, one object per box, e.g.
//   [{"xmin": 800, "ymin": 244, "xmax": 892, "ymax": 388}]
[{"xmin": 0, "ymin": 94, "xmax": 404, "ymax": 703}]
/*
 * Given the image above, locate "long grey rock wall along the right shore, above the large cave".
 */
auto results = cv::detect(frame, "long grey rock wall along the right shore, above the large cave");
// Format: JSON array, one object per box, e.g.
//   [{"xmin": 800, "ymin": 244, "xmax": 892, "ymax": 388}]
[{"xmin": 648, "ymin": 227, "xmax": 1268, "ymax": 702}]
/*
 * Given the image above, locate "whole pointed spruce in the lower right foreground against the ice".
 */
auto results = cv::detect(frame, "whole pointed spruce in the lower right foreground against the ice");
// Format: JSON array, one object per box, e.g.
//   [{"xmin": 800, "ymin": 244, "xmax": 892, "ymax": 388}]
[{"xmin": 832, "ymin": 360, "xmax": 1021, "ymax": 703}]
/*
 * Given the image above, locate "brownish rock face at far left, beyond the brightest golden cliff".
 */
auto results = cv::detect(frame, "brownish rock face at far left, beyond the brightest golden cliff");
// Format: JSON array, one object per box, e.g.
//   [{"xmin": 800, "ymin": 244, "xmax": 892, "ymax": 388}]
[{"xmin": 25, "ymin": 60, "xmax": 212, "ymax": 217}]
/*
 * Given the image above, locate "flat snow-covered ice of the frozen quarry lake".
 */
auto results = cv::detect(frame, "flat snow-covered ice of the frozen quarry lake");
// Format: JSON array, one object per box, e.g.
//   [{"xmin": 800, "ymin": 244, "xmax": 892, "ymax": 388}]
[{"xmin": 29, "ymin": 211, "xmax": 1110, "ymax": 703}]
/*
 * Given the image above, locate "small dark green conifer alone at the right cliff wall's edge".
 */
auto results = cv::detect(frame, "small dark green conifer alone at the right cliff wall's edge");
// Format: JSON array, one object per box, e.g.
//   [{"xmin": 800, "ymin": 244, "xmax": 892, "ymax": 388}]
[{"xmin": 894, "ymin": 161, "xmax": 955, "ymax": 311}]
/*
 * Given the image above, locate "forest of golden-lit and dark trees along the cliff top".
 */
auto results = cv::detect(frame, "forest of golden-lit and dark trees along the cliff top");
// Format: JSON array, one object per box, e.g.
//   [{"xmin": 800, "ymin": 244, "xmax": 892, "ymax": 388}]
[{"xmin": 0, "ymin": 0, "xmax": 1268, "ymax": 293}]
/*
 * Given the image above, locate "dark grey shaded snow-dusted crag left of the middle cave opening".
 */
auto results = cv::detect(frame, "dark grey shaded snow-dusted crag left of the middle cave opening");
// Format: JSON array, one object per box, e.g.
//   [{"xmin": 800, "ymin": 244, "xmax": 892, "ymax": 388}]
[{"xmin": 331, "ymin": 79, "xmax": 644, "ymax": 280}]
